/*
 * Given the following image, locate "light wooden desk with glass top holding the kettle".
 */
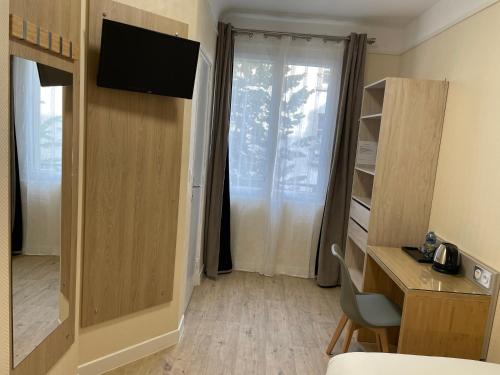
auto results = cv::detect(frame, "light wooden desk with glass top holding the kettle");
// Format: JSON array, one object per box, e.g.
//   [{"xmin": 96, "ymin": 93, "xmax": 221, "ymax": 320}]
[{"xmin": 358, "ymin": 246, "xmax": 491, "ymax": 360}]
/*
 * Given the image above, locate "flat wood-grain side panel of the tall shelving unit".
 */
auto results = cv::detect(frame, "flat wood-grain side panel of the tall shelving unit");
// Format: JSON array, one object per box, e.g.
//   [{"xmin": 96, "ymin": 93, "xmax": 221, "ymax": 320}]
[{"xmin": 368, "ymin": 78, "xmax": 448, "ymax": 246}]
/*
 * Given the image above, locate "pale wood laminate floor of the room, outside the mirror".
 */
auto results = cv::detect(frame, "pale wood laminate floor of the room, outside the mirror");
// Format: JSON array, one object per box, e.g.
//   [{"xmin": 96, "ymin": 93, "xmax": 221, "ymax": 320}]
[{"xmin": 107, "ymin": 272, "xmax": 362, "ymax": 375}]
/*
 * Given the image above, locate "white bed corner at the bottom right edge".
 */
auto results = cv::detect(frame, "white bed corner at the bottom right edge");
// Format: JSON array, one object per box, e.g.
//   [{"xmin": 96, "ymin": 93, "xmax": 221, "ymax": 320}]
[{"xmin": 327, "ymin": 353, "xmax": 500, "ymax": 375}]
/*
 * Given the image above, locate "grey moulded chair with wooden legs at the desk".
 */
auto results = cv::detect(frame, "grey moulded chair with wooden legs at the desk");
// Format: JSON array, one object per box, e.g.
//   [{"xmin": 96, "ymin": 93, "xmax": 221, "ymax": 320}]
[{"xmin": 326, "ymin": 244, "xmax": 401, "ymax": 355}]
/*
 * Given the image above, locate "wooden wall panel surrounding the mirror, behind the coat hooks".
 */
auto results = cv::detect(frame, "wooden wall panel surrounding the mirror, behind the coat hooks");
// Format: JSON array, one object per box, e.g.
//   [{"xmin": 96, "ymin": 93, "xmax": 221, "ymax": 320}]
[{"xmin": 9, "ymin": 0, "xmax": 81, "ymax": 375}]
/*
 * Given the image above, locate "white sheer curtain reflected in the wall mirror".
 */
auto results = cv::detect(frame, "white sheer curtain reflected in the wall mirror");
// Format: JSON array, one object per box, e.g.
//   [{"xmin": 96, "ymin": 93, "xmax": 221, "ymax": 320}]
[{"xmin": 13, "ymin": 57, "xmax": 62, "ymax": 255}]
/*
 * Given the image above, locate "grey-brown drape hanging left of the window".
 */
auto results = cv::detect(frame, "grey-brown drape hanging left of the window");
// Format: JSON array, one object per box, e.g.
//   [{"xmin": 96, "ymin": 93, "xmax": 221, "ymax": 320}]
[{"xmin": 203, "ymin": 22, "xmax": 234, "ymax": 278}]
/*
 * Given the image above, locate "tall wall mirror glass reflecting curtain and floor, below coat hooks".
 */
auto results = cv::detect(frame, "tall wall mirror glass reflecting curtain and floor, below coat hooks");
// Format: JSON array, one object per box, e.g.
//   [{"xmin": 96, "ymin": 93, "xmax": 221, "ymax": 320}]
[{"xmin": 10, "ymin": 57, "xmax": 72, "ymax": 367}]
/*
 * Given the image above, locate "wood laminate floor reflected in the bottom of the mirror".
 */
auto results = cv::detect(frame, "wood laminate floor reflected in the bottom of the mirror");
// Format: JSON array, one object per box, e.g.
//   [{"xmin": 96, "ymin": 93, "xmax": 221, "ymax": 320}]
[{"xmin": 12, "ymin": 255, "xmax": 60, "ymax": 365}]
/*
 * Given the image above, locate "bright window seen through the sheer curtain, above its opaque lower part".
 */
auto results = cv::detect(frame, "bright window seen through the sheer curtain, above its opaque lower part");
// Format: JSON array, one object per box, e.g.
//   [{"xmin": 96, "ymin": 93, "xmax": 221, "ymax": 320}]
[{"xmin": 229, "ymin": 36, "xmax": 342, "ymax": 200}]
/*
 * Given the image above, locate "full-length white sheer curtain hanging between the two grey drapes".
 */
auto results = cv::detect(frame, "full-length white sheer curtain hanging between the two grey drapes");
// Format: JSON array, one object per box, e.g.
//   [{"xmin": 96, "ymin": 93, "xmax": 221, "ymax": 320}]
[{"xmin": 229, "ymin": 35, "xmax": 344, "ymax": 277}]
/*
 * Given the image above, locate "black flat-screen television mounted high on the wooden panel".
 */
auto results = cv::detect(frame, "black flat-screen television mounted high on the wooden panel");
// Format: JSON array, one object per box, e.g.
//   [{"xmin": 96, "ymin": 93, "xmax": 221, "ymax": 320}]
[{"xmin": 97, "ymin": 19, "xmax": 200, "ymax": 99}]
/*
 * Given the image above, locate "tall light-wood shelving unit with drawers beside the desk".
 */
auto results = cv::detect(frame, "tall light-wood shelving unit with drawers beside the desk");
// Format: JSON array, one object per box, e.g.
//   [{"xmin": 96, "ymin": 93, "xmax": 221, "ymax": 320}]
[{"xmin": 346, "ymin": 78, "xmax": 448, "ymax": 288}]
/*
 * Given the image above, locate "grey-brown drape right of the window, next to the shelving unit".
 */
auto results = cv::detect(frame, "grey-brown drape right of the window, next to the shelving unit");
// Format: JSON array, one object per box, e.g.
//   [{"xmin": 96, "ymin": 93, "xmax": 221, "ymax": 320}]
[{"xmin": 316, "ymin": 33, "xmax": 367, "ymax": 287}]
